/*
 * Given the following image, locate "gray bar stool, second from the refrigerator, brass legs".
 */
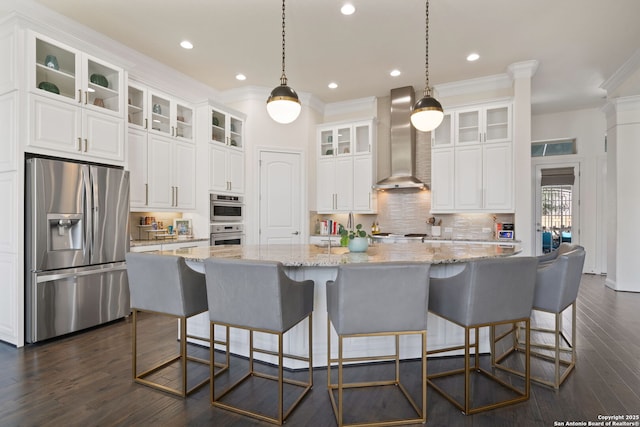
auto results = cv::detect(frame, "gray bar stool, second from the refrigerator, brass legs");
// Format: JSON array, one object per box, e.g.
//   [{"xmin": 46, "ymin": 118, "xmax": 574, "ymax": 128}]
[{"xmin": 204, "ymin": 258, "xmax": 314, "ymax": 425}]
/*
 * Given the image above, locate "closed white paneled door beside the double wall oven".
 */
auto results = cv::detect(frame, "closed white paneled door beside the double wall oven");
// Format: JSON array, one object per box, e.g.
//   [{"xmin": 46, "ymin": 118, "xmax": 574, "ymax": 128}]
[{"xmin": 260, "ymin": 151, "xmax": 304, "ymax": 245}]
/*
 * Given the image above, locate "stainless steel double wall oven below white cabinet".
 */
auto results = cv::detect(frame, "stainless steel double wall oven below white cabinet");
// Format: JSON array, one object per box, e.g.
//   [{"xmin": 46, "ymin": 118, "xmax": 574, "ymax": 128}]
[{"xmin": 209, "ymin": 194, "xmax": 244, "ymax": 246}]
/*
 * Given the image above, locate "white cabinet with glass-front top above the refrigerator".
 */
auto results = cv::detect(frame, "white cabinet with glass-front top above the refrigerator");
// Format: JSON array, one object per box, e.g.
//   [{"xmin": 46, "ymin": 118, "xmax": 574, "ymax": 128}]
[{"xmin": 27, "ymin": 33, "xmax": 124, "ymax": 162}]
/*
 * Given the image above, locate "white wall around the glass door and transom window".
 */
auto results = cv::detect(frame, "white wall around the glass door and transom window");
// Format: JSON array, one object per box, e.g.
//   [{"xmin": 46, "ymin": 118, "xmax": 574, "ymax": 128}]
[{"xmin": 531, "ymin": 109, "xmax": 606, "ymax": 273}]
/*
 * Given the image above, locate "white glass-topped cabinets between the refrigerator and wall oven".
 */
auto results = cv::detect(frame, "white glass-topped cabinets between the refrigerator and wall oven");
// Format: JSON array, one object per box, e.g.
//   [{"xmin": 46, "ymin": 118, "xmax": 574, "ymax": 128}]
[{"xmin": 127, "ymin": 83, "xmax": 196, "ymax": 210}]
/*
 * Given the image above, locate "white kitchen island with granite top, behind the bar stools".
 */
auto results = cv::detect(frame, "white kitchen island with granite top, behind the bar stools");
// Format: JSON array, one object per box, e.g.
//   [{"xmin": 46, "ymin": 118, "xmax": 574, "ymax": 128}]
[{"xmin": 160, "ymin": 241, "xmax": 521, "ymax": 368}]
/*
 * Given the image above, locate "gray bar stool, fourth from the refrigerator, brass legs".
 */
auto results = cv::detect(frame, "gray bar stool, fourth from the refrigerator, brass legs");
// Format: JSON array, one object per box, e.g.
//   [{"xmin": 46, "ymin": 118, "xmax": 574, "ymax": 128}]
[{"xmin": 427, "ymin": 257, "xmax": 538, "ymax": 415}]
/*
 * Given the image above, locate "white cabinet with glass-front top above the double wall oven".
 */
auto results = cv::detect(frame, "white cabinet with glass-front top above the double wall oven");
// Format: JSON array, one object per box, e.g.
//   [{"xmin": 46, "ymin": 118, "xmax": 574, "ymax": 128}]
[{"xmin": 202, "ymin": 106, "xmax": 244, "ymax": 194}]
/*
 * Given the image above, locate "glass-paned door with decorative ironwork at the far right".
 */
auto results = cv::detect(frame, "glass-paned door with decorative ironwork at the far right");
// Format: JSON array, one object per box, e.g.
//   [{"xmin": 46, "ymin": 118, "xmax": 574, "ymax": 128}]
[{"xmin": 534, "ymin": 162, "xmax": 580, "ymax": 255}]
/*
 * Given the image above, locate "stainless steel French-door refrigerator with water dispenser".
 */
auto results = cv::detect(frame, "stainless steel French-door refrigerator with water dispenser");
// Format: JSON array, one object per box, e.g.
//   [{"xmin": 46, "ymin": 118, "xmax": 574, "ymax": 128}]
[{"xmin": 25, "ymin": 158, "xmax": 130, "ymax": 343}]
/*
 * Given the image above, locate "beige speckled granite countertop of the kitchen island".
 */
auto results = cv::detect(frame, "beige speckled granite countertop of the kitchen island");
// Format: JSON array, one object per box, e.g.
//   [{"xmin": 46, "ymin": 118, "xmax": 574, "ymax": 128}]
[{"xmin": 160, "ymin": 242, "xmax": 522, "ymax": 267}]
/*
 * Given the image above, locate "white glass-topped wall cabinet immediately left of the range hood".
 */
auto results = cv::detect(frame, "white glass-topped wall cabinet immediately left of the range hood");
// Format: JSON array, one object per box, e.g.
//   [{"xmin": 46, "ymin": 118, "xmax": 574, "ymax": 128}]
[{"xmin": 316, "ymin": 120, "xmax": 377, "ymax": 214}]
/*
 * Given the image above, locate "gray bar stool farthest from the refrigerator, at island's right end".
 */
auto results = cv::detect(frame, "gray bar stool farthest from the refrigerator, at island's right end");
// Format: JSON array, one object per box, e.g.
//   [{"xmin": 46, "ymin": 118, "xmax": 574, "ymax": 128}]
[{"xmin": 495, "ymin": 245, "xmax": 585, "ymax": 389}]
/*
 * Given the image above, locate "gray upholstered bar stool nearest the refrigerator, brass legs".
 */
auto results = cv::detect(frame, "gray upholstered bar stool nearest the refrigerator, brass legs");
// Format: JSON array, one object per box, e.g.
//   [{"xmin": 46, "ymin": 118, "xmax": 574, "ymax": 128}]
[{"xmin": 126, "ymin": 253, "xmax": 228, "ymax": 397}]
